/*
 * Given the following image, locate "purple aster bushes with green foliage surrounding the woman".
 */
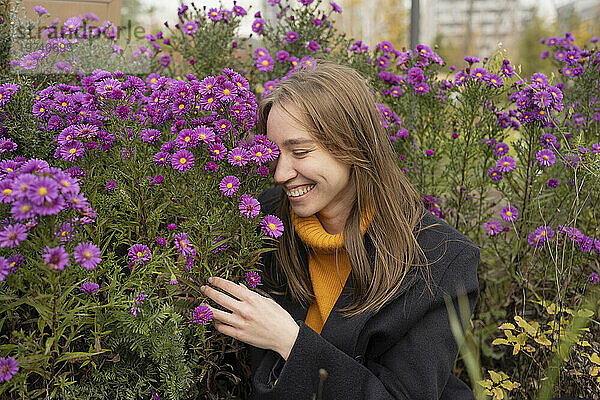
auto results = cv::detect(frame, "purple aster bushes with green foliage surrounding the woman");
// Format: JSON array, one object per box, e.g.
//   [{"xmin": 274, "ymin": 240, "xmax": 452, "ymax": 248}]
[{"xmin": 0, "ymin": 0, "xmax": 600, "ymax": 399}]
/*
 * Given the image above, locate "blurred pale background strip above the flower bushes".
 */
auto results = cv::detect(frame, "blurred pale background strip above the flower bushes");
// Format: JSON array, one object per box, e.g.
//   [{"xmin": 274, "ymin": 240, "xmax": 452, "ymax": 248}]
[{"xmin": 11, "ymin": 0, "xmax": 600, "ymax": 73}]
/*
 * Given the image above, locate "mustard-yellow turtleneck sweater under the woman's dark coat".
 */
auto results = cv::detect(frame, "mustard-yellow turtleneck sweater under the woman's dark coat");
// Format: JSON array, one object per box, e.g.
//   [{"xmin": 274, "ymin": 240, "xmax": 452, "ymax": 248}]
[{"xmin": 290, "ymin": 210, "xmax": 372, "ymax": 334}]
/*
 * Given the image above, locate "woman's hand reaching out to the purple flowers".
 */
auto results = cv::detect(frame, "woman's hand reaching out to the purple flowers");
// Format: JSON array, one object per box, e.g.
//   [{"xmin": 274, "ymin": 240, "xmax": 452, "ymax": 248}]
[{"xmin": 200, "ymin": 277, "xmax": 300, "ymax": 360}]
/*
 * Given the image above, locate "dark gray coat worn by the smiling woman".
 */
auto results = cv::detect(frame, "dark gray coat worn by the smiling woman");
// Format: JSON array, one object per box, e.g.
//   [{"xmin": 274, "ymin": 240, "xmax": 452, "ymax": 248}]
[{"xmin": 250, "ymin": 188, "xmax": 479, "ymax": 400}]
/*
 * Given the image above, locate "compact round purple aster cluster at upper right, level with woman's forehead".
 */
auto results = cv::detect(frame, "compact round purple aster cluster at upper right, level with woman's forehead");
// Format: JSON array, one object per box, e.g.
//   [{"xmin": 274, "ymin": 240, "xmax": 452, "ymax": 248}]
[{"xmin": 510, "ymin": 73, "xmax": 563, "ymax": 126}]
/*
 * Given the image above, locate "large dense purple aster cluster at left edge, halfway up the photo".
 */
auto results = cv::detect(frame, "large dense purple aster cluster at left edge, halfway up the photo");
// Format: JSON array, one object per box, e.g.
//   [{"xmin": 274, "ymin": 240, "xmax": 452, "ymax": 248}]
[{"xmin": 0, "ymin": 158, "xmax": 96, "ymax": 248}]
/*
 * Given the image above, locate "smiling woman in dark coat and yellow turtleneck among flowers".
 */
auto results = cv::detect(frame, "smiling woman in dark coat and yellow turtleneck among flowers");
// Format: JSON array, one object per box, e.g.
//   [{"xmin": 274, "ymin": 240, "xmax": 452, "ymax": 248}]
[{"xmin": 203, "ymin": 63, "xmax": 479, "ymax": 400}]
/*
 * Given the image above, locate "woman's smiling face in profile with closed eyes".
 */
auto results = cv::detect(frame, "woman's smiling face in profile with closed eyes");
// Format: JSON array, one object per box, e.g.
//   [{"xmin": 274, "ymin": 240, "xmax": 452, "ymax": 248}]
[{"xmin": 267, "ymin": 105, "xmax": 356, "ymax": 228}]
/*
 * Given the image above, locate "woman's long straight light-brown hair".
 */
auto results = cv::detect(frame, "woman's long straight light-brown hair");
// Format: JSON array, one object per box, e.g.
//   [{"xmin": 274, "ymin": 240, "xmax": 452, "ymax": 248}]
[{"xmin": 258, "ymin": 63, "xmax": 423, "ymax": 317}]
